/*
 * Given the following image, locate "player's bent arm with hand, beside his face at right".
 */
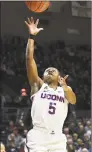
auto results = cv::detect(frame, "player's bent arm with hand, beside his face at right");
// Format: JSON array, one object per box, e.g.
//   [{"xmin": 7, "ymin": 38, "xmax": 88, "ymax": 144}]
[{"xmin": 59, "ymin": 75, "xmax": 76, "ymax": 104}]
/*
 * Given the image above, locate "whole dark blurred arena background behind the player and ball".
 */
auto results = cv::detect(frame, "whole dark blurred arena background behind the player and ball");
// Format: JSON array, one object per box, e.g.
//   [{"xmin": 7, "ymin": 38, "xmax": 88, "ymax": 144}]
[{"xmin": 0, "ymin": 1, "xmax": 92, "ymax": 152}]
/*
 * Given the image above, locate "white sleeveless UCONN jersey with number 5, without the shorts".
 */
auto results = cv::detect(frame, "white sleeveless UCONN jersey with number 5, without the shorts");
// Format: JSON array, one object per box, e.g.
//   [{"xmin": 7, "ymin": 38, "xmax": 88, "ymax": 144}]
[{"xmin": 31, "ymin": 83, "xmax": 68, "ymax": 132}]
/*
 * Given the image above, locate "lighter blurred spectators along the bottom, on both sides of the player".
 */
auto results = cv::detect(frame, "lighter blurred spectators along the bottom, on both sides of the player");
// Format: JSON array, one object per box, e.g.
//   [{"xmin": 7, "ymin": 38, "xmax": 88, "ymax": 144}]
[{"xmin": 1, "ymin": 118, "xmax": 92, "ymax": 152}]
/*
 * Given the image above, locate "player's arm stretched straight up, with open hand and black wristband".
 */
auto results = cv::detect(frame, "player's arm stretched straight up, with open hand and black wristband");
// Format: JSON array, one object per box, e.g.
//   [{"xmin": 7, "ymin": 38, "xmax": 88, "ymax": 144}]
[{"xmin": 25, "ymin": 17, "xmax": 43, "ymax": 87}]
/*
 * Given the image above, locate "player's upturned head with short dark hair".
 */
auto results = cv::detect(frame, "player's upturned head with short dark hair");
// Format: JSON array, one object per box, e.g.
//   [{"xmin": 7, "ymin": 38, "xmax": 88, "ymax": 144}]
[{"xmin": 43, "ymin": 67, "xmax": 59, "ymax": 83}]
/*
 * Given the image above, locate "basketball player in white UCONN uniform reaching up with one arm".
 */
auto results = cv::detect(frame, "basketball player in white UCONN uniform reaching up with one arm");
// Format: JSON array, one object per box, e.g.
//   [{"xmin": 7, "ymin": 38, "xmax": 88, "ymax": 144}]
[{"xmin": 25, "ymin": 17, "xmax": 76, "ymax": 152}]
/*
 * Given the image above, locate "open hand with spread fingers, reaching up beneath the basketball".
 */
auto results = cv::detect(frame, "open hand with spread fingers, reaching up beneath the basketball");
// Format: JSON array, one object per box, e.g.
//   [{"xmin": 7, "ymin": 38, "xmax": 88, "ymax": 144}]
[{"xmin": 25, "ymin": 17, "xmax": 43, "ymax": 35}]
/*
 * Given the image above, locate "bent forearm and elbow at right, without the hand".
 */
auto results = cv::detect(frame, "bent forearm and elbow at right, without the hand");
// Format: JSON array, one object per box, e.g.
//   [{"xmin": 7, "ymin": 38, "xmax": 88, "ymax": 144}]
[{"xmin": 63, "ymin": 86, "xmax": 76, "ymax": 104}]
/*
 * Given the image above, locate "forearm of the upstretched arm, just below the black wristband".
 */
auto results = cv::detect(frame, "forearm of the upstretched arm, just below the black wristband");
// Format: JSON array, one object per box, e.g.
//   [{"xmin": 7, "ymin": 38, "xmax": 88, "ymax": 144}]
[{"xmin": 26, "ymin": 39, "xmax": 34, "ymax": 64}]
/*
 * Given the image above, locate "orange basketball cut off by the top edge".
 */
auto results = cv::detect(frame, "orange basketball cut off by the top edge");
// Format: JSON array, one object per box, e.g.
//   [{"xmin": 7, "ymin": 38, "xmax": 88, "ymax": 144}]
[{"xmin": 25, "ymin": 1, "xmax": 50, "ymax": 13}]
